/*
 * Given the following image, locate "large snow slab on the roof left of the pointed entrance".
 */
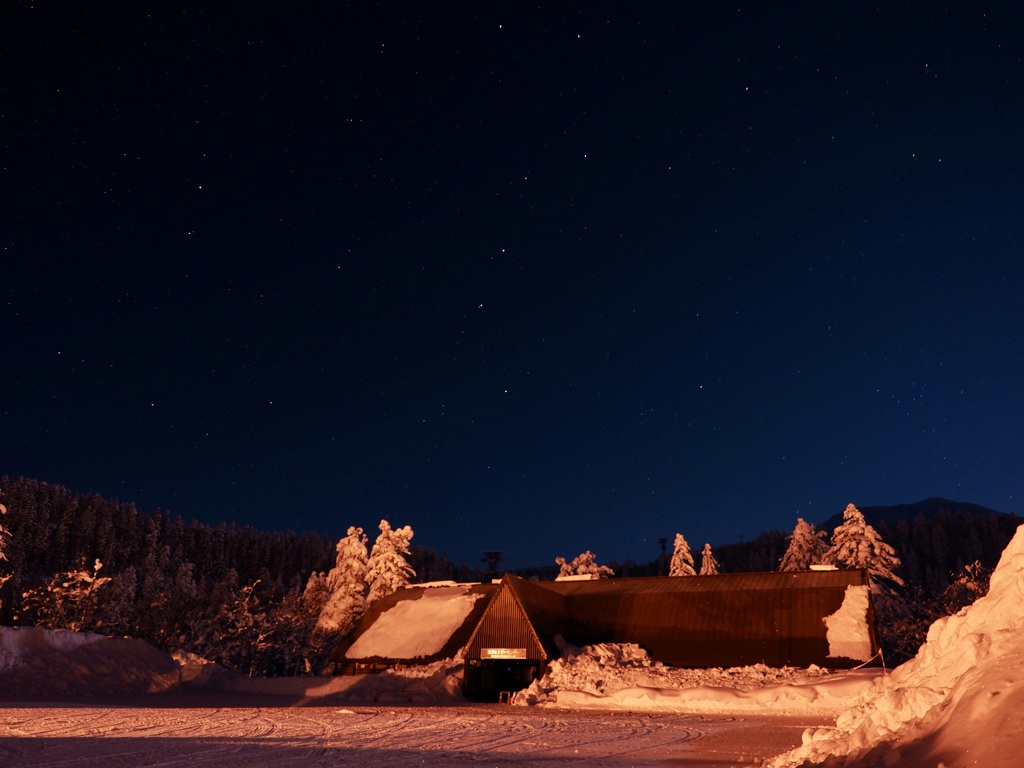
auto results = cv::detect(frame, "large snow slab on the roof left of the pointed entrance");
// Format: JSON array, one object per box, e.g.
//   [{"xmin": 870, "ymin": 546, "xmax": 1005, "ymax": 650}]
[{"xmin": 345, "ymin": 586, "xmax": 483, "ymax": 659}]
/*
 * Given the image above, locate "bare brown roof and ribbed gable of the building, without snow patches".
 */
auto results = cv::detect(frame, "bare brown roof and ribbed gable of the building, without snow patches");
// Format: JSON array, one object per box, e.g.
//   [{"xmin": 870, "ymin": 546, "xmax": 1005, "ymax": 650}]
[{"xmin": 332, "ymin": 570, "xmax": 878, "ymax": 668}]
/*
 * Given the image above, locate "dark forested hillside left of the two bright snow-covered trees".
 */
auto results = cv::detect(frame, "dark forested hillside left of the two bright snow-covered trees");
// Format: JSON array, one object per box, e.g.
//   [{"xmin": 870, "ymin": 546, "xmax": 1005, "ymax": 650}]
[{"xmin": 0, "ymin": 477, "xmax": 480, "ymax": 675}]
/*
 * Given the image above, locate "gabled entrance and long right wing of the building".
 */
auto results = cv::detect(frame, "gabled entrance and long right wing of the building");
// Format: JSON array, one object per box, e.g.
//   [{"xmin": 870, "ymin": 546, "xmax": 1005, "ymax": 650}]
[{"xmin": 465, "ymin": 570, "xmax": 879, "ymax": 698}]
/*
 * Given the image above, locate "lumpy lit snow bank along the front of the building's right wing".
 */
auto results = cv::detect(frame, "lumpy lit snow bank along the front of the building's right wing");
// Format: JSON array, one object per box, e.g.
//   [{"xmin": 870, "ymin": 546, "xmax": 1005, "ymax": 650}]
[{"xmin": 513, "ymin": 643, "xmax": 878, "ymax": 715}]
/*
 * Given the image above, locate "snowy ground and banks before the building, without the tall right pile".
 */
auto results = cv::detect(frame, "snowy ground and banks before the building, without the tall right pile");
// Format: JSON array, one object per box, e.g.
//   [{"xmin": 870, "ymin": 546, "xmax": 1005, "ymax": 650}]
[{"xmin": 0, "ymin": 628, "xmax": 869, "ymax": 768}]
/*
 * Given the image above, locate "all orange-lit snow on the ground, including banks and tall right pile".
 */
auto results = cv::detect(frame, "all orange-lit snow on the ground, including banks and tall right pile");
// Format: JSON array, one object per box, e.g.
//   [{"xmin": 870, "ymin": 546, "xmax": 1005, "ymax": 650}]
[{"xmin": 0, "ymin": 520, "xmax": 1024, "ymax": 768}]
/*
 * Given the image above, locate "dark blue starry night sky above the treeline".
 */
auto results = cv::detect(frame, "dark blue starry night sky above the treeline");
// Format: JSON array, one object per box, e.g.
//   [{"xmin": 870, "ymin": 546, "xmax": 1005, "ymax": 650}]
[{"xmin": 0, "ymin": 0, "xmax": 1024, "ymax": 567}]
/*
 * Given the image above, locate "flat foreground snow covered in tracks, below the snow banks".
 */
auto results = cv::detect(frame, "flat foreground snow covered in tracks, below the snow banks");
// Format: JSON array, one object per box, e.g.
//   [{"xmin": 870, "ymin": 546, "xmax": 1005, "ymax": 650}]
[{"xmin": 0, "ymin": 702, "xmax": 720, "ymax": 768}]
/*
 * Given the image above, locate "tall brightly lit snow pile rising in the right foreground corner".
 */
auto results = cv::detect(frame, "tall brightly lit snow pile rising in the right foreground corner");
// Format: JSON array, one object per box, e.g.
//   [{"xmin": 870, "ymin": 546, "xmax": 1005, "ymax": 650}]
[{"xmin": 769, "ymin": 526, "xmax": 1024, "ymax": 768}]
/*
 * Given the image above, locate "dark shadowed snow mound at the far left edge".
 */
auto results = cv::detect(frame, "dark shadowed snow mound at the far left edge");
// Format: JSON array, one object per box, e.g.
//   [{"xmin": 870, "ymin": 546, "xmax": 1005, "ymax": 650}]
[{"xmin": 0, "ymin": 627, "xmax": 180, "ymax": 700}]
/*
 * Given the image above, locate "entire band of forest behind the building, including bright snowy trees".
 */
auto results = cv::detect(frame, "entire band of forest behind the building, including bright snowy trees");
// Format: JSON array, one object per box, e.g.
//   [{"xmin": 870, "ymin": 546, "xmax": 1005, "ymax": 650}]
[{"xmin": 0, "ymin": 477, "xmax": 1022, "ymax": 675}]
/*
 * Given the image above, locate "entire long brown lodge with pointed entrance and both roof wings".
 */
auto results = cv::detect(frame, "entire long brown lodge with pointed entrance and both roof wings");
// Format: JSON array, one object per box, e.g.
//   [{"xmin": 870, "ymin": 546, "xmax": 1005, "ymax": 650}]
[{"xmin": 334, "ymin": 569, "xmax": 879, "ymax": 699}]
